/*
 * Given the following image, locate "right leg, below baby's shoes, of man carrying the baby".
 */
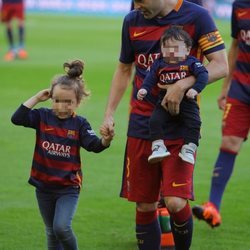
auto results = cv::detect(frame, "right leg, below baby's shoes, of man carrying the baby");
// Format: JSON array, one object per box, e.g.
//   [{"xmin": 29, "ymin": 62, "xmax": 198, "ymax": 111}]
[{"xmin": 162, "ymin": 140, "xmax": 194, "ymax": 250}]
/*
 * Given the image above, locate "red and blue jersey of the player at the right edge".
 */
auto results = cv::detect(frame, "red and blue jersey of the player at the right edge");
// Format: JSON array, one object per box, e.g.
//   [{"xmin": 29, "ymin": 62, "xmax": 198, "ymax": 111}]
[{"xmin": 228, "ymin": 0, "xmax": 250, "ymax": 104}]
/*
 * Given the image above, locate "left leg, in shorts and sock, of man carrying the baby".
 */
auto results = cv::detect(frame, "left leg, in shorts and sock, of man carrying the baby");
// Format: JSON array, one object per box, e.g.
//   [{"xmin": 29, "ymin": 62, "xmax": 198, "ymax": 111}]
[{"xmin": 120, "ymin": 137, "xmax": 161, "ymax": 250}]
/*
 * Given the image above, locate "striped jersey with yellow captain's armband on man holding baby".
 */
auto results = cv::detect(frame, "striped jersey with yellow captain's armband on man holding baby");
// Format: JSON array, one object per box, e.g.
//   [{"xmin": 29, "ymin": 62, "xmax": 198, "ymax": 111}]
[{"xmin": 120, "ymin": 0, "xmax": 225, "ymax": 139}]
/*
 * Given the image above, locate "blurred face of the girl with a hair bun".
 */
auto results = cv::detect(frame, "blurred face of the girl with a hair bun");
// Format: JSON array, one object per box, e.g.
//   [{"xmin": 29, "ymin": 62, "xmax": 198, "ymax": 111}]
[{"xmin": 51, "ymin": 85, "xmax": 78, "ymax": 119}]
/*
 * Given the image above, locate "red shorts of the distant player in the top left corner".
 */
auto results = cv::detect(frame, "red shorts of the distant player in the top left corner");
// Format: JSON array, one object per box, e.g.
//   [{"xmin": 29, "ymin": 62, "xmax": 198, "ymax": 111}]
[{"xmin": 1, "ymin": 3, "xmax": 24, "ymax": 22}]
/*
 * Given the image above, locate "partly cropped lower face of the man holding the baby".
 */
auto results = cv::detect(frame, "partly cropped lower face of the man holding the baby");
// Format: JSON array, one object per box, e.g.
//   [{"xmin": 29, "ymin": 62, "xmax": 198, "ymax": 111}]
[{"xmin": 134, "ymin": 0, "xmax": 166, "ymax": 19}]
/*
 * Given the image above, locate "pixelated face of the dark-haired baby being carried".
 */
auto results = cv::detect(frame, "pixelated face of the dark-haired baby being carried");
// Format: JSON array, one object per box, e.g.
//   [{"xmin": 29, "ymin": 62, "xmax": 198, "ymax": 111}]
[{"xmin": 161, "ymin": 39, "xmax": 190, "ymax": 63}]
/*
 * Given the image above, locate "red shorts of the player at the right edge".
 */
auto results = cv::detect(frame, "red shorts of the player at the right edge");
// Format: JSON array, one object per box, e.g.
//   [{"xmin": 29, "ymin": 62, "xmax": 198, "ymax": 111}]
[{"xmin": 222, "ymin": 98, "xmax": 250, "ymax": 139}]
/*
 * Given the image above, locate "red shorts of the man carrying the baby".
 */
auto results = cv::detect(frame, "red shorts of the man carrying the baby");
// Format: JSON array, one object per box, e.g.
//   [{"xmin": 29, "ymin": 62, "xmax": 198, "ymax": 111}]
[{"xmin": 120, "ymin": 137, "xmax": 194, "ymax": 203}]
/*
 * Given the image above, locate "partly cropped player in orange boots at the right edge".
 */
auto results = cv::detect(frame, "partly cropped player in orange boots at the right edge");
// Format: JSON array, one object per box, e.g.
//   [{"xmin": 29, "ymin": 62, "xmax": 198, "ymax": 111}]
[{"xmin": 192, "ymin": 0, "xmax": 250, "ymax": 227}]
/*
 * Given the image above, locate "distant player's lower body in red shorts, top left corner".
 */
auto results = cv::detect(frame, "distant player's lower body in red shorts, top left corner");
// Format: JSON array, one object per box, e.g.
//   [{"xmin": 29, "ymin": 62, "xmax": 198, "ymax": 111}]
[{"xmin": 1, "ymin": 0, "xmax": 28, "ymax": 61}]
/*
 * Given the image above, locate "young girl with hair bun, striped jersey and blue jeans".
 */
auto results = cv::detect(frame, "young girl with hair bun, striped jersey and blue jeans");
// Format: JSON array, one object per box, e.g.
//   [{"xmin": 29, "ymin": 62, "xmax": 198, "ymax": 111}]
[{"xmin": 11, "ymin": 60, "xmax": 113, "ymax": 250}]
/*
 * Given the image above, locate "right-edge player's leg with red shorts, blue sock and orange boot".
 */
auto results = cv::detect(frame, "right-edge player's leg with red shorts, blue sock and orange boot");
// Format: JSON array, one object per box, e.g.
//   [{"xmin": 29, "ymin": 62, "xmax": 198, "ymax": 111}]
[{"xmin": 192, "ymin": 94, "xmax": 250, "ymax": 228}]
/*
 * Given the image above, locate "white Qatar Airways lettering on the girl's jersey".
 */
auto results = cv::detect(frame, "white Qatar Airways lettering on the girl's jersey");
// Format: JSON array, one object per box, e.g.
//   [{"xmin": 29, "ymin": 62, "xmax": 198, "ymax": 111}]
[{"xmin": 42, "ymin": 141, "xmax": 71, "ymax": 158}]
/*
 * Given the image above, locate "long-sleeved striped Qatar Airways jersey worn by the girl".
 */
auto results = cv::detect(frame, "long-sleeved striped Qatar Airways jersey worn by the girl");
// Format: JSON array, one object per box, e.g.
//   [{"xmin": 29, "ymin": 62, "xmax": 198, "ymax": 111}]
[{"xmin": 12, "ymin": 105, "xmax": 106, "ymax": 190}]
